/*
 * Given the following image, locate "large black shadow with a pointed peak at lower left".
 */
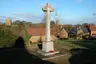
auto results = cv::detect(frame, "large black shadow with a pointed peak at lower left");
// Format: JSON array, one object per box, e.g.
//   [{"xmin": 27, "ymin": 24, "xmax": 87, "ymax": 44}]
[{"xmin": 0, "ymin": 37, "xmax": 55, "ymax": 64}]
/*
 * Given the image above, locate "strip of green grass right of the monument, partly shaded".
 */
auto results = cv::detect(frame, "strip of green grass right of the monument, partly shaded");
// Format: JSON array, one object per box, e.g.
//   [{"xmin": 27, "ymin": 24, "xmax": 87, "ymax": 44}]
[{"xmin": 55, "ymin": 40, "xmax": 96, "ymax": 50}]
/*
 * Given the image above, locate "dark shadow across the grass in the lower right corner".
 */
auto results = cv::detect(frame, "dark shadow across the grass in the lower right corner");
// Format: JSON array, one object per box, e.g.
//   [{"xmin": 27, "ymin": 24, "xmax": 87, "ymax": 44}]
[{"xmin": 69, "ymin": 41, "xmax": 96, "ymax": 64}]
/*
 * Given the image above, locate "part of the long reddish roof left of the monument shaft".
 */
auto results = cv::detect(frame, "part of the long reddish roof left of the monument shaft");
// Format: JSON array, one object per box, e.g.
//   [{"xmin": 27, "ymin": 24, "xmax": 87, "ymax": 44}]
[{"xmin": 27, "ymin": 28, "xmax": 46, "ymax": 36}]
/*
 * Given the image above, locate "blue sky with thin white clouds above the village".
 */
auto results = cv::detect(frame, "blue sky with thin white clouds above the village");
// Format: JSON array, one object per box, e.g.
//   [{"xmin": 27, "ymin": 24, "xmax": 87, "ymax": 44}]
[{"xmin": 0, "ymin": 0, "xmax": 96, "ymax": 24}]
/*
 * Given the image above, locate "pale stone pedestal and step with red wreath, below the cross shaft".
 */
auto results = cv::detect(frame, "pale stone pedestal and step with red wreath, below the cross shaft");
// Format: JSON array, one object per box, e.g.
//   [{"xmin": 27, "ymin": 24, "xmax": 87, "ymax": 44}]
[{"xmin": 38, "ymin": 41, "xmax": 59, "ymax": 56}]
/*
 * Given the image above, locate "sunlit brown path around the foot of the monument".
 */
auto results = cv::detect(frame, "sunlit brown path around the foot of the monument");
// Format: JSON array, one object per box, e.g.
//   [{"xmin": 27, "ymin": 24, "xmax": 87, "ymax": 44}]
[{"xmin": 25, "ymin": 44, "xmax": 71, "ymax": 64}]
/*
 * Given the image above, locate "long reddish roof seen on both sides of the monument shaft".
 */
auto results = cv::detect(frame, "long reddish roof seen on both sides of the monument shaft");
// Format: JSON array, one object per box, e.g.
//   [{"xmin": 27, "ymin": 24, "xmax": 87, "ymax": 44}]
[{"xmin": 27, "ymin": 25, "xmax": 65, "ymax": 36}]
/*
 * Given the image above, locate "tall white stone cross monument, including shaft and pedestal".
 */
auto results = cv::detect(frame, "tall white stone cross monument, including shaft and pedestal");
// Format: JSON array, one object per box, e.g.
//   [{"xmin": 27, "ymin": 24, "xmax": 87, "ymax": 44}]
[{"xmin": 38, "ymin": 3, "xmax": 59, "ymax": 56}]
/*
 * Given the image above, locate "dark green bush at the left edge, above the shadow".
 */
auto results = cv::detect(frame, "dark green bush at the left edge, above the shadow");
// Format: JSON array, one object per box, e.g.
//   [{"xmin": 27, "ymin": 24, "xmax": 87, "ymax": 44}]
[{"xmin": 0, "ymin": 28, "xmax": 17, "ymax": 47}]
